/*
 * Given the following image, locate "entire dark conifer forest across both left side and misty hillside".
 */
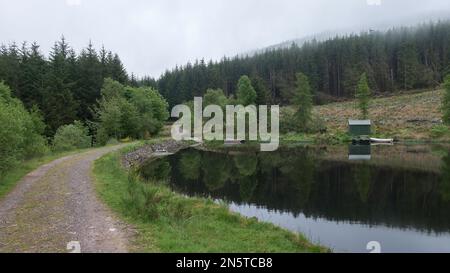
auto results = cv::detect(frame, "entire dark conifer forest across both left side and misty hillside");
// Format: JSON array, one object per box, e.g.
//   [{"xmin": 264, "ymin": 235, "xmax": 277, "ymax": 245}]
[{"xmin": 0, "ymin": 21, "xmax": 450, "ymax": 137}]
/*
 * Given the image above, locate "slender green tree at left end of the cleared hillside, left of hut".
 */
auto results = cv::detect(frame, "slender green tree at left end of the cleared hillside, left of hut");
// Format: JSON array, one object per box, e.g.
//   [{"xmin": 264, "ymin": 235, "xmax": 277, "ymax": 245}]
[{"xmin": 291, "ymin": 73, "xmax": 313, "ymax": 131}]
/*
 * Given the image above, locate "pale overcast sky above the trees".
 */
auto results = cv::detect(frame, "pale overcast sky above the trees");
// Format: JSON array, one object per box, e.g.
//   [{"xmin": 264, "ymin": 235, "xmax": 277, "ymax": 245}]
[{"xmin": 0, "ymin": 0, "xmax": 450, "ymax": 77}]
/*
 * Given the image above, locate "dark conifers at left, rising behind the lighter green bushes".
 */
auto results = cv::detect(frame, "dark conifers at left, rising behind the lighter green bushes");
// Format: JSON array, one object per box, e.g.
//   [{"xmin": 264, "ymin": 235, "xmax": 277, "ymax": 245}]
[{"xmin": 0, "ymin": 37, "xmax": 130, "ymax": 137}]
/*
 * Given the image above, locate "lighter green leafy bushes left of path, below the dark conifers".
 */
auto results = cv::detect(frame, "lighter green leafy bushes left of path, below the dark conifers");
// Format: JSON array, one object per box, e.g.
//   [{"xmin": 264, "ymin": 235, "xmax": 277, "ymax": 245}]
[{"xmin": 0, "ymin": 75, "xmax": 169, "ymax": 174}]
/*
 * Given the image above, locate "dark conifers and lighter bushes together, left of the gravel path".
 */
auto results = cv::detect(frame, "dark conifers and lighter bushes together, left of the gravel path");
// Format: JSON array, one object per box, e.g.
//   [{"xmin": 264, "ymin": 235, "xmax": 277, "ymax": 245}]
[{"xmin": 0, "ymin": 38, "xmax": 169, "ymax": 174}]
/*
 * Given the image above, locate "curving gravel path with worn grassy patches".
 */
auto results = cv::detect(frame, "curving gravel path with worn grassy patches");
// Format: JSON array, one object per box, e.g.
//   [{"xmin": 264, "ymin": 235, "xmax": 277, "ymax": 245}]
[{"xmin": 0, "ymin": 146, "xmax": 132, "ymax": 253}]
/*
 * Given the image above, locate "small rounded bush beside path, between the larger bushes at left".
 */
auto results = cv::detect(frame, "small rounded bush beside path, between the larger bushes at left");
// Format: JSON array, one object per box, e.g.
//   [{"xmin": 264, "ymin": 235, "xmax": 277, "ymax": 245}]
[{"xmin": 53, "ymin": 121, "xmax": 92, "ymax": 151}]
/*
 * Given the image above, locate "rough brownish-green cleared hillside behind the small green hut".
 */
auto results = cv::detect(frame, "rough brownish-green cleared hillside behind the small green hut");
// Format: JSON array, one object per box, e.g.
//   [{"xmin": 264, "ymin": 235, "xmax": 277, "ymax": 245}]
[{"xmin": 313, "ymin": 90, "xmax": 450, "ymax": 142}]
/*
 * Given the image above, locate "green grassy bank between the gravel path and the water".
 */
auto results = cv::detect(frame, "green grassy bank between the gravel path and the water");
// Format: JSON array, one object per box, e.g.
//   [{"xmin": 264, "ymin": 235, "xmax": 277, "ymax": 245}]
[{"xmin": 93, "ymin": 143, "xmax": 326, "ymax": 252}]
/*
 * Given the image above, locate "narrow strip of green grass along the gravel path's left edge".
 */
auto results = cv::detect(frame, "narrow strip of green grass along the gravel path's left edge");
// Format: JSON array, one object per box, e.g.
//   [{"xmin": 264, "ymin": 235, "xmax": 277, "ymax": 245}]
[{"xmin": 0, "ymin": 149, "xmax": 92, "ymax": 199}]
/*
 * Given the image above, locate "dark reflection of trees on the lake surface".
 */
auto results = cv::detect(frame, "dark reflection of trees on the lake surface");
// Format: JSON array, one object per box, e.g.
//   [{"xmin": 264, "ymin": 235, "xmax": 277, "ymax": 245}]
[{"xmin": 142, "ymin": 148, "xmax": 450, "ymax": 232}]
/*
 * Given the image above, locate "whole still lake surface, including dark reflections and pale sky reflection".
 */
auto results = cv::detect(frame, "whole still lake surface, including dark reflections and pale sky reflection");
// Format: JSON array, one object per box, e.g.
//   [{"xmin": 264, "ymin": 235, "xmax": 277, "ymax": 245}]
[{"xmin": 141, "ymin": 143, "xmax": 450, "ymax": 252}]
